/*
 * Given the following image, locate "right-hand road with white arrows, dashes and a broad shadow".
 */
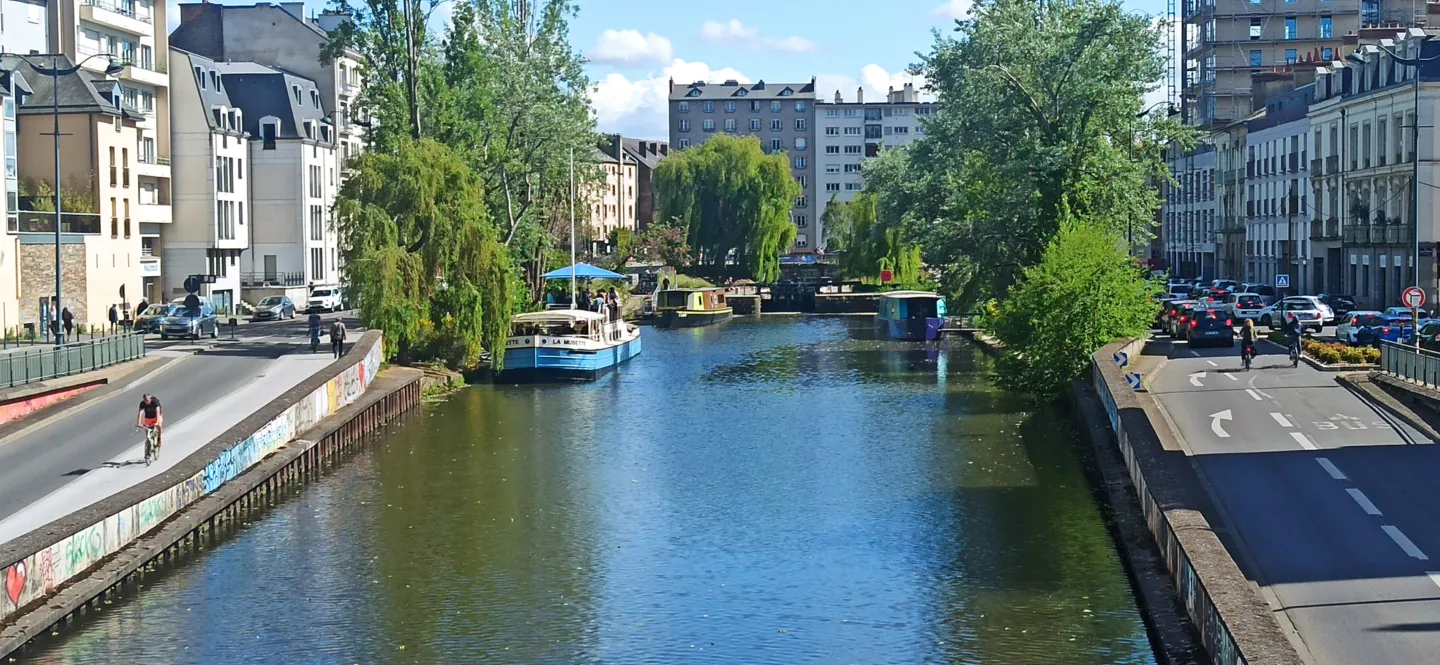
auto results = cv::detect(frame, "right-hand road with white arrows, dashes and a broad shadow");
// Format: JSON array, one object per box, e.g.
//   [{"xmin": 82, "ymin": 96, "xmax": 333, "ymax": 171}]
[{"xmin": 1151, "ymin": 331, "xmax": 1440, "ymax": 665}]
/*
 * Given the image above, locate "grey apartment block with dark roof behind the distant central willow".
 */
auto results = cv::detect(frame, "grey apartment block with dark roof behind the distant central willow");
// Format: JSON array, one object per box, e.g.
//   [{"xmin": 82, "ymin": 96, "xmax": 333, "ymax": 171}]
[{"xmin": 670, "ymin": 78, "xmax": 821, "ymax": 253}]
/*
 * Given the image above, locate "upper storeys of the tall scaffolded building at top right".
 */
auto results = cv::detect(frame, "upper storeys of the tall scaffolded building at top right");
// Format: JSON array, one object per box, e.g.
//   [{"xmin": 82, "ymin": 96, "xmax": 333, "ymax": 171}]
[{"xmin": 1179, "ymin": 0, "xmax": 1353, "ymax": 127}]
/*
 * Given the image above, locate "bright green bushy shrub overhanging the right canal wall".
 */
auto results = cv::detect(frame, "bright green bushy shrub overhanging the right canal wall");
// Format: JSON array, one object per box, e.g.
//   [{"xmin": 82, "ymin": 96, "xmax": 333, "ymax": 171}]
[{"xmin": 989, "ymin": 220, "xmax": 1159, "ymax": 397}]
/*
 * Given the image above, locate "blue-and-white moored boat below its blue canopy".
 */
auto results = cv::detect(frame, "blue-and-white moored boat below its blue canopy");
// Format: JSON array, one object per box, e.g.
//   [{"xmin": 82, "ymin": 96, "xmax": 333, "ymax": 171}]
[{"xmin": 500, "ymin": 309, "xmax": 639, "ymax": 381}]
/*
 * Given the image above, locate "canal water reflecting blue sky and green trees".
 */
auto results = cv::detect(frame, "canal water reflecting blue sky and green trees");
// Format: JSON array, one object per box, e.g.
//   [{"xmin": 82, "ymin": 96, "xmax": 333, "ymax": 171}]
[{"xmin": 22, "ymin": 317, "xmax": 1155, "ymax": 665}]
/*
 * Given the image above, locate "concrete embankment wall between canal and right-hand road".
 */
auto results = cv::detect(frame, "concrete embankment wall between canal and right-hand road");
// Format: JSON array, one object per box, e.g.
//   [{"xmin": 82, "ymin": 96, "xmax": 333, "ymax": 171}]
[{"xmin": 1090, "ymin": 340, "xmax": 1302, "ymax": 665}]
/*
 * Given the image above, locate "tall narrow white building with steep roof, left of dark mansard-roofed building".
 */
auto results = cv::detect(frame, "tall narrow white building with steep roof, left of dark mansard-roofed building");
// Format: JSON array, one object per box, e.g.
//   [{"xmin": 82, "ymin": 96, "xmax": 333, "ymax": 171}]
[{"xmin": 164, "ymin": 48, "xmax": 251, "ymax": 309}]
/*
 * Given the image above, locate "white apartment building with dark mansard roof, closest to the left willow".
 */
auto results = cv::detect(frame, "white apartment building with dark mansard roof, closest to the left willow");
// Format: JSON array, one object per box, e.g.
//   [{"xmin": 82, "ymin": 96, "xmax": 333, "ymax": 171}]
[{"xmin": 213, "ymin": 62, "xmax": 341, "ymax": 304}]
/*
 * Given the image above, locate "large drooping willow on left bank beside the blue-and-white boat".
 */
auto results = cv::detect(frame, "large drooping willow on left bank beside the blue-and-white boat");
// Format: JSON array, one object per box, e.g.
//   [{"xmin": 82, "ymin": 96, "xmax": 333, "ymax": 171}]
[{"xmin": 334, "ymin": 140, "xmax": 514, "ymax": 367}]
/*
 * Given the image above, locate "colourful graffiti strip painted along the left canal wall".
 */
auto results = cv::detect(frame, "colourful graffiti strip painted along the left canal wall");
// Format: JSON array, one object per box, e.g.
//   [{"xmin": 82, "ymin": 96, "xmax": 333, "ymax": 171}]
[{"xmin": 0, "ymin": 338, "xmax": 382, "ymax": 622}]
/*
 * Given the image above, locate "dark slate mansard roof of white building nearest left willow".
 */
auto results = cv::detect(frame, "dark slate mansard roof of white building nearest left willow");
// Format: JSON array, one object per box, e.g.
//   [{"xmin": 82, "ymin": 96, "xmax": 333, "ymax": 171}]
[{"xmin": 215, "ymin": 62, "xmax": 334, "ymax": 143}]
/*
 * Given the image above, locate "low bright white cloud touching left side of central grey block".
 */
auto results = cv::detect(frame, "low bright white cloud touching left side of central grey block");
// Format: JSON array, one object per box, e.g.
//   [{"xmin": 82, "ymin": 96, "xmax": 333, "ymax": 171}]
[{"xmin": 590, "ymin": 58, "xmax": 752, "ymax": 140}]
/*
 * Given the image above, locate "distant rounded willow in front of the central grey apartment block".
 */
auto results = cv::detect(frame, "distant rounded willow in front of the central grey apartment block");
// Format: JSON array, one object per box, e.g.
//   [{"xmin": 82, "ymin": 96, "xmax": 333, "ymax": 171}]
[{"xmin": 655, "ymin": 135, "xmax": 802, "ymax": 282}]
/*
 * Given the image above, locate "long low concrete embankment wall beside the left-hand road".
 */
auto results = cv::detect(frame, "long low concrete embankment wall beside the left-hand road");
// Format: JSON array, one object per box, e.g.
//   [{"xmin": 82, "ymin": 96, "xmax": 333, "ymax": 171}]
[{"xmin": 0, "ymin": 331, "xmax": 394, "ymax": 633}]
